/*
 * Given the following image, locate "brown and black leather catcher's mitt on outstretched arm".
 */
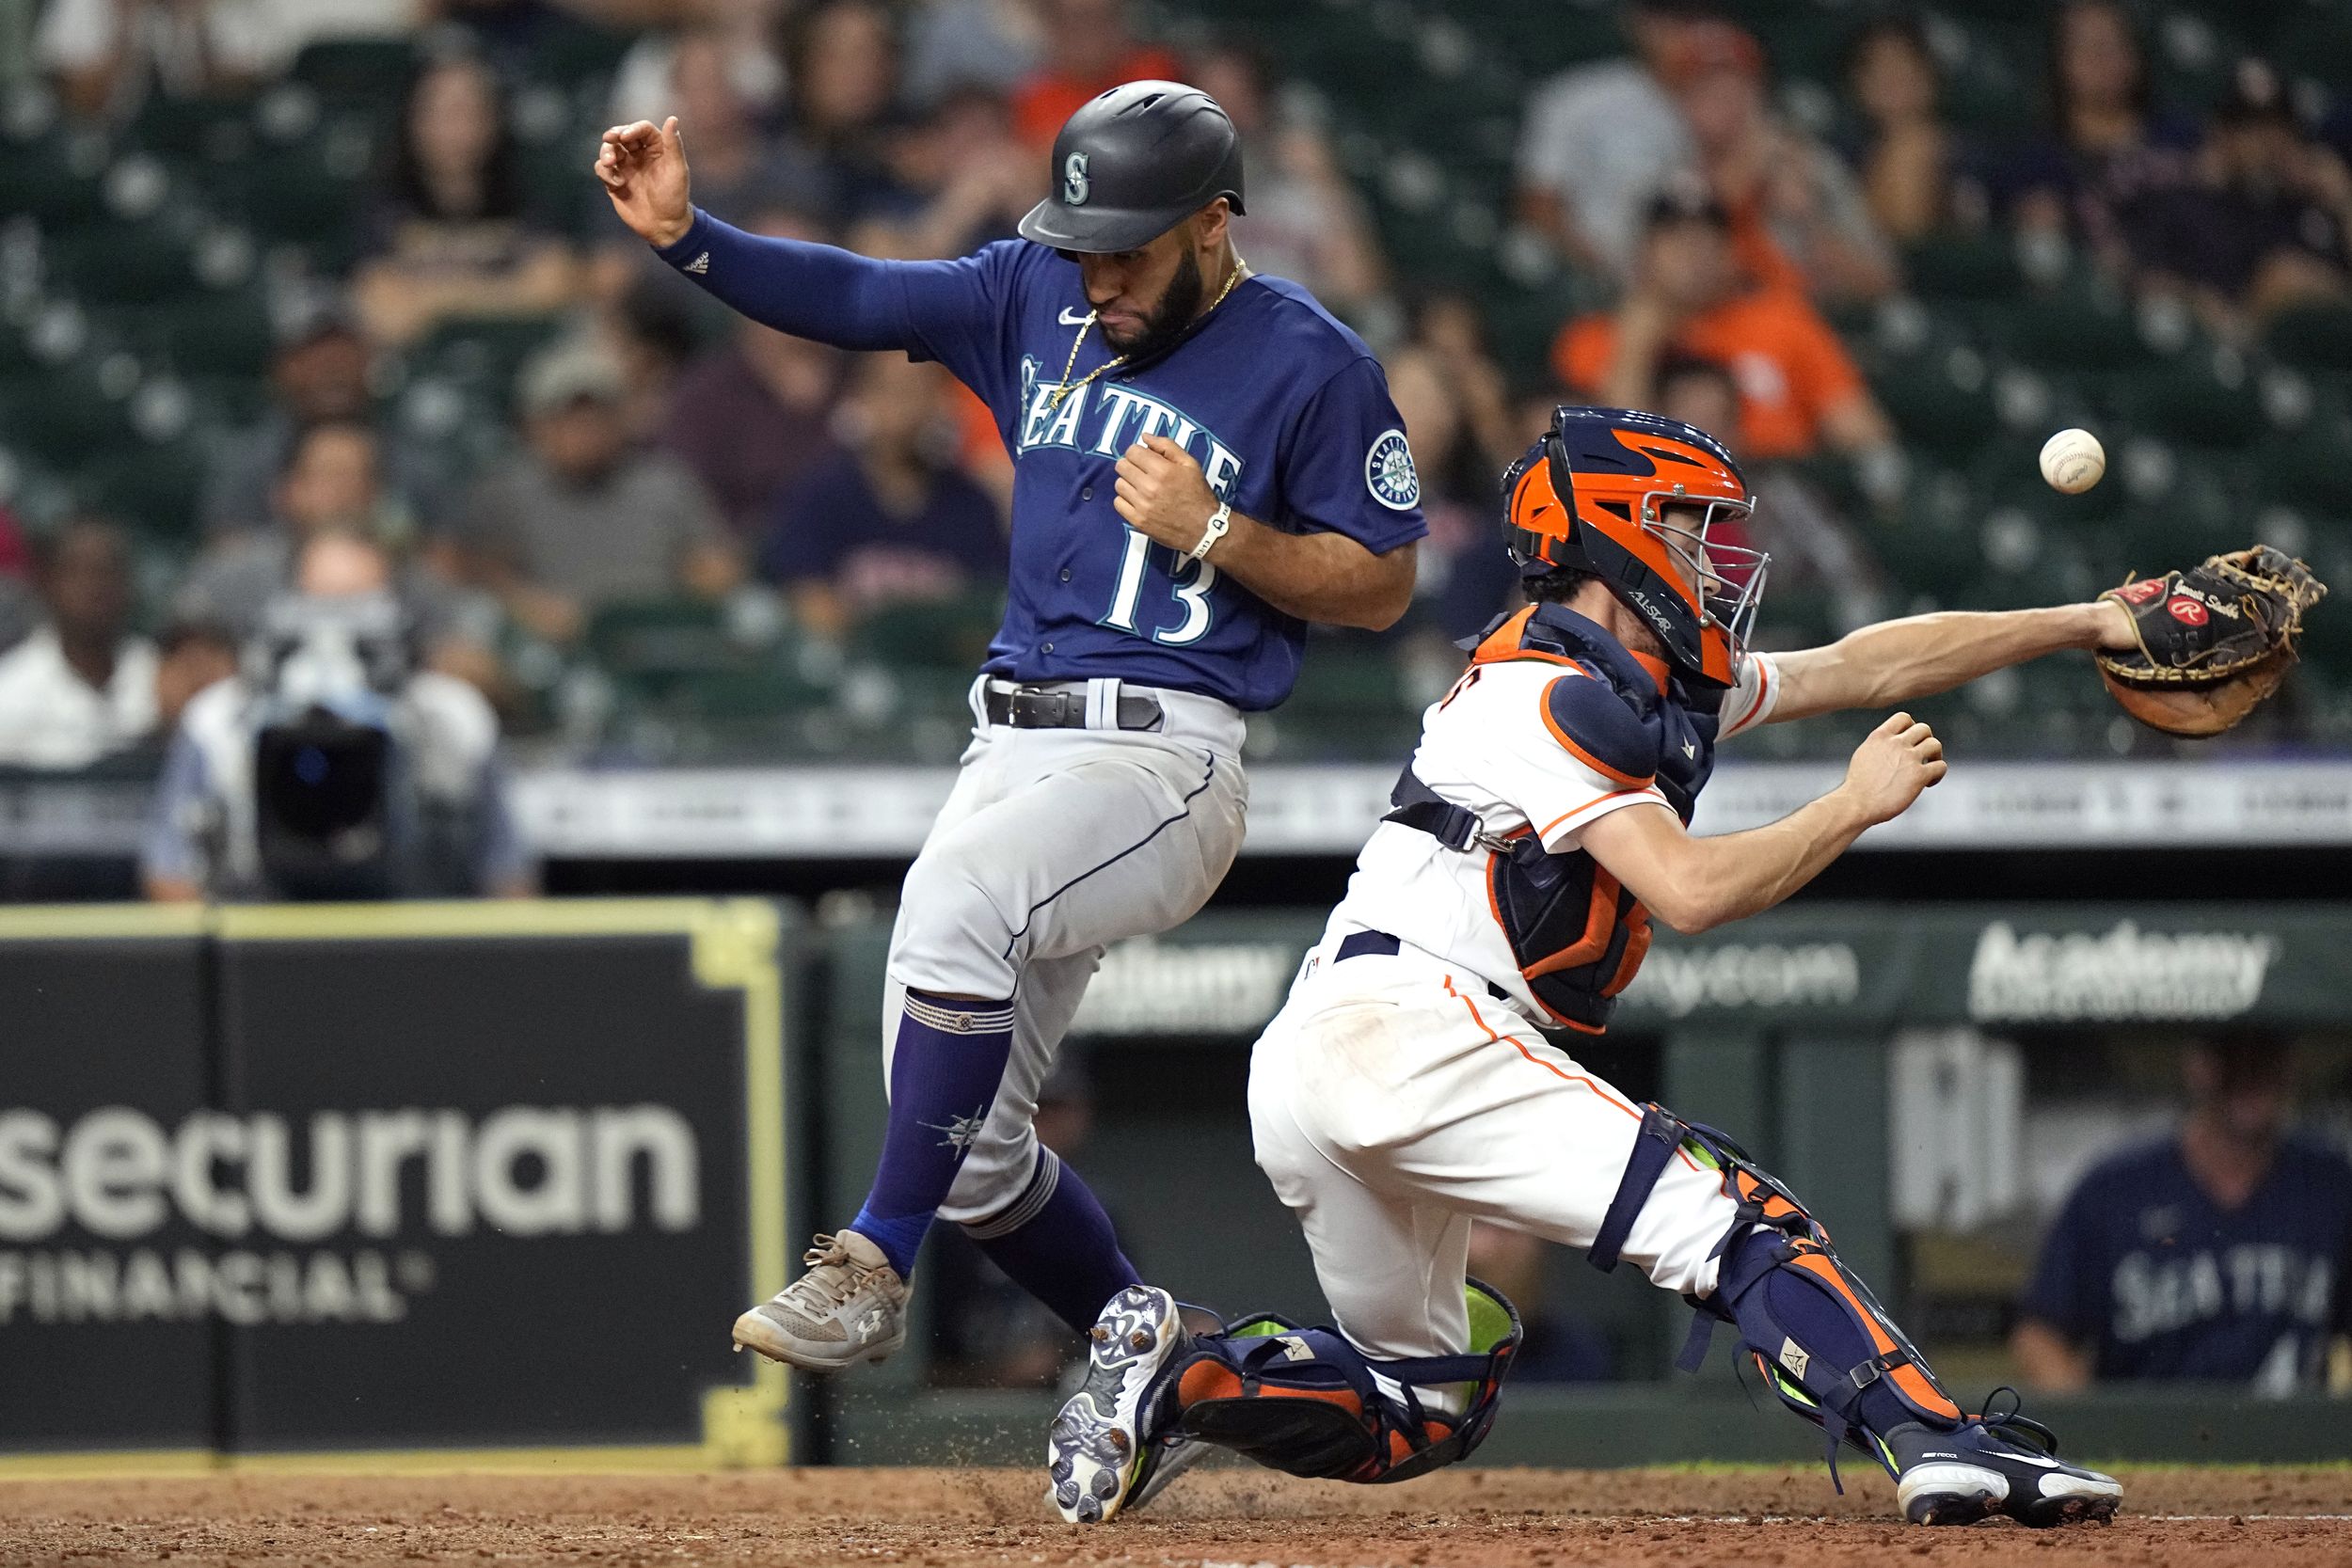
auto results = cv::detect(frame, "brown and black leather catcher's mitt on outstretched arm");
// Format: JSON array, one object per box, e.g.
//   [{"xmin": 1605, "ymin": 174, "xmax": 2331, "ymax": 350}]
[{"xmin": 2098, "ymin": 546, "xmax": 2328, "ymax": 736}]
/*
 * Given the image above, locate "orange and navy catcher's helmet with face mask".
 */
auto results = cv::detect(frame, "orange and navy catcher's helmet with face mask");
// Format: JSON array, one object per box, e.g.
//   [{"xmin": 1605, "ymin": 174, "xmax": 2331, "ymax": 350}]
[{"xmin": 1503, "ymin": 409, "xmax": 1769, "ymax": 687}]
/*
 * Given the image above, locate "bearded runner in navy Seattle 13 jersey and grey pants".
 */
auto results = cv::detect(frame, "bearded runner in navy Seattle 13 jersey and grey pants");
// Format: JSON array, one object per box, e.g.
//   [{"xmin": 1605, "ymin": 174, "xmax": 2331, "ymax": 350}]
[{"xmin": 596, "ymin": 82, "xmax": 1423, "ymax": 1419}]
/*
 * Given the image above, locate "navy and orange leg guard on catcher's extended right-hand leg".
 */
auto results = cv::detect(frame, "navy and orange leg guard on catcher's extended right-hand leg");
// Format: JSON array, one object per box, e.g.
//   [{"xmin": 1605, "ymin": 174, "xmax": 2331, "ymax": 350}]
[{"xmin": 1590, "ymin": 1105, "xmax": 1962, "ymax": 1491}]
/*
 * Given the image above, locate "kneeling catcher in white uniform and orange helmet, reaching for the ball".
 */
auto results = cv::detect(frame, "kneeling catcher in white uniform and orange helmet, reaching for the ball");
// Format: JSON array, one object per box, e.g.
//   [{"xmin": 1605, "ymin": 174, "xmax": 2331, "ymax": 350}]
[{"xmin": 1049, "ymin": 409, "xmax": 2308, "ymax": 1526}]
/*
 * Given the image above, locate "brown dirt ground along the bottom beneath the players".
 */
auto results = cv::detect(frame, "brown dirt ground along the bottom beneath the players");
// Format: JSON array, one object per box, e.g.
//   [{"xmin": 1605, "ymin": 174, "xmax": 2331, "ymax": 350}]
[{"xmin": 0, "ymin": 1469, "xmax": 2352, "ymax": 1568}]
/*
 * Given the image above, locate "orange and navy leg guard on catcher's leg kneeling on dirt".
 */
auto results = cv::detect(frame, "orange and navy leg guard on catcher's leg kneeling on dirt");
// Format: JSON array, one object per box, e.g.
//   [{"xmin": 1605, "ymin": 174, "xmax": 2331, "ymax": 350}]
[{"xmin": 1165, "ymin": 1279, "xmax": 1519, "ymax": 1483}]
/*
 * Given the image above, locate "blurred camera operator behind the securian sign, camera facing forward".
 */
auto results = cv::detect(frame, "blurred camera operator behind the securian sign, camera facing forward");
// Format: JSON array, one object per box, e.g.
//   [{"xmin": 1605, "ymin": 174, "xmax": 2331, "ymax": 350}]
[{"xmin": 139, "ymin": 529, "xmax": 532, "ymax": 900}]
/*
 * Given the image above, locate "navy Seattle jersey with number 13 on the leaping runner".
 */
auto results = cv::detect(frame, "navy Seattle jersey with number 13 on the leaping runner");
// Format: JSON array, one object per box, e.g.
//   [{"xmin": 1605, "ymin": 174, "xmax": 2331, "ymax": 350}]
[{"xmin": 661, "ymin": 214, "xmax": 1425, "ymax": 710}]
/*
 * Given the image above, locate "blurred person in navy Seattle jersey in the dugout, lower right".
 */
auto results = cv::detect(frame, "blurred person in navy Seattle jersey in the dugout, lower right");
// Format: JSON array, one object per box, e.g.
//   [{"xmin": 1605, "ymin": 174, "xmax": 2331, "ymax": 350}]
[{"xmin": 2009, "ymin": 1032, "xmax": 2352, "ymax": 1397}]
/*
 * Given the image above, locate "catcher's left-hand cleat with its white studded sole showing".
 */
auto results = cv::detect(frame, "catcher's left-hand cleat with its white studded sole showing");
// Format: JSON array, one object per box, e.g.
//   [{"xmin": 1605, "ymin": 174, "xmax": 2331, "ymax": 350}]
[{"xmin": 1044, "ymin": 1286, "xmax": 1200, "ymax": 1524}]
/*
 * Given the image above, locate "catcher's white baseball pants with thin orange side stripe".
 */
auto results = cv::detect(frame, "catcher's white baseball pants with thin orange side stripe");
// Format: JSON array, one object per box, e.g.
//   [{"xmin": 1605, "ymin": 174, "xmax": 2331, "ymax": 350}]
[{"xmin": 1249, "ymin": 936, "xmax": 1736, "ymax": 1359}]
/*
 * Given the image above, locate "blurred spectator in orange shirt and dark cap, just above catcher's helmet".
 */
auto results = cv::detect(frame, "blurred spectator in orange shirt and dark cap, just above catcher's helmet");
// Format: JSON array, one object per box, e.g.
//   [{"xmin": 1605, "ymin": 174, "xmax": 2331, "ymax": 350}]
[{"xmin": 1552, "ymin": 181, "xmax": 1894, "ymax": 463}]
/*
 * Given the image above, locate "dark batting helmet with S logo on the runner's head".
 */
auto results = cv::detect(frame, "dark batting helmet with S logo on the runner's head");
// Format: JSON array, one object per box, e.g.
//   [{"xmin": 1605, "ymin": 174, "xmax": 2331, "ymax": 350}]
[{"xmin": 1021, "ymin": 82, "xmax": 1242, "ymax": 254}]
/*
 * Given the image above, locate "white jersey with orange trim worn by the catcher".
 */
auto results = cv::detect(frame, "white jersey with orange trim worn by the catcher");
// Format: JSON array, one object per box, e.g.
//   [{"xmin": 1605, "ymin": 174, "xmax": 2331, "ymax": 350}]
[{"xmin": 1325, "ymin": 654, "xmax": 1781, "ymax": 1022}]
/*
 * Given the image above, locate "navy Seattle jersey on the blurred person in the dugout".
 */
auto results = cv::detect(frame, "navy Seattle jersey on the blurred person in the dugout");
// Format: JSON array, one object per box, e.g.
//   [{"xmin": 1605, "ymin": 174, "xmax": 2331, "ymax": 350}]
[{"xmin": 2023, "ymin": 1138, "xmax": 2352, "ymax": 1394}]
